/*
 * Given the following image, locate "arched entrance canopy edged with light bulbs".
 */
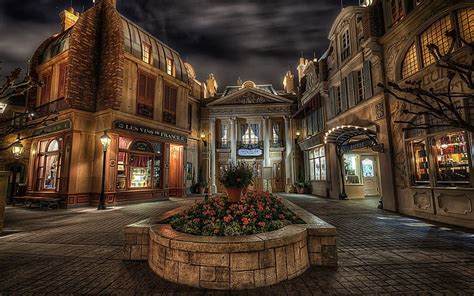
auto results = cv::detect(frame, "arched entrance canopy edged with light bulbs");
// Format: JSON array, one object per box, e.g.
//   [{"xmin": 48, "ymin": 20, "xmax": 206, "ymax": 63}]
[{"xmin": 324, "ymin": 125, "xmax": 383, "ymax": 154}]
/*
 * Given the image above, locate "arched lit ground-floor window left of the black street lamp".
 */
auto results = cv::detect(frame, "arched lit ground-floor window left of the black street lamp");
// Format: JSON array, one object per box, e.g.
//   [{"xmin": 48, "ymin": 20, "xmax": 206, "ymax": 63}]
[{"xmin": 36, "ymin": 138, "xmax": 61, "ymax": 191}]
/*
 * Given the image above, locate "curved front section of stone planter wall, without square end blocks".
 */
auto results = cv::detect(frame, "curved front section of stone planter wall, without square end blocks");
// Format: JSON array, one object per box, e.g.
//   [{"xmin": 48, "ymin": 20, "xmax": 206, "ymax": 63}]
[{"xmin": 148, "ymin": 224, "xmax": 310, "ymax": 290}]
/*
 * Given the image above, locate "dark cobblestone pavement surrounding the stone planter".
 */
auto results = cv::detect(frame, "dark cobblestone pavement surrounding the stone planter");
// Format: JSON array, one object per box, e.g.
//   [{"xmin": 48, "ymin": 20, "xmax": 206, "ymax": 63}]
[{"xmin": 0, "ymin": 195, "xmax": 474, "ymax": 295}]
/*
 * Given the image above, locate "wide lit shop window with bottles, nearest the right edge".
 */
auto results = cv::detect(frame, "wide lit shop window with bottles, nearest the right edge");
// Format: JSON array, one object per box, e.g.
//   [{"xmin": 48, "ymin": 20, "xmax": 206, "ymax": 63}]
[{"xmin": 433, "ymin": 132, "xmax": 471, "ymax": 186}]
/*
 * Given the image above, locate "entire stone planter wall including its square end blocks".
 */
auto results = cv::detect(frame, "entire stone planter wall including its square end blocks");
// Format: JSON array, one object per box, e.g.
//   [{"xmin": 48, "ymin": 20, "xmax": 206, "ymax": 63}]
[{"xmin": 124, "ymin": 201, "xmax": 337, "ymax": 290}]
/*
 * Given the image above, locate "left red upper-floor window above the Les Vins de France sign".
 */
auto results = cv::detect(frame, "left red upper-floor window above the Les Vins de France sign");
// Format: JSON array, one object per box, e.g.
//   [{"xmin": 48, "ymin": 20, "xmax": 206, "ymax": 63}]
[{"xmin": 137, "ymin": 72, "xmax": 156, "ymax": 118}]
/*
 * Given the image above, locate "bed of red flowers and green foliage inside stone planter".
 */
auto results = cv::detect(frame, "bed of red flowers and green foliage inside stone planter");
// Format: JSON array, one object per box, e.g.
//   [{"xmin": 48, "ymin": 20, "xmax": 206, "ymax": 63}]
[{"xmin": 169, "ymin": 192, "xmax": 303, "ymax": 236}]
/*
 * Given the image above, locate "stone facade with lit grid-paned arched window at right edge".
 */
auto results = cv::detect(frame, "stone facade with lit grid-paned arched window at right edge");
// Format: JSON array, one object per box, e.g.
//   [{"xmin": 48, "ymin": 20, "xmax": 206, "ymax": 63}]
[{"xmin": 379, "ymin": 0, "xmax": 474, "ymax": 227}]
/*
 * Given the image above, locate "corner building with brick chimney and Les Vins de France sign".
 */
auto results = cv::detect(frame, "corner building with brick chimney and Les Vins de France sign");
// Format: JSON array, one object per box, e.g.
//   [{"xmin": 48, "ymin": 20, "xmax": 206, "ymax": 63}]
[{"xmin": 20, "ymin": 0, "xmax": 204, "ymax": 206}]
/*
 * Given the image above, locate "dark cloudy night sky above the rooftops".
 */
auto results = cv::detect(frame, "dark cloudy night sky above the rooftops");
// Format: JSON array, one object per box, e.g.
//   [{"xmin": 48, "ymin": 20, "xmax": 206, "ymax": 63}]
[{"xmin": 0, "ymin": 0, "xmax": 358, "ymax": 91}]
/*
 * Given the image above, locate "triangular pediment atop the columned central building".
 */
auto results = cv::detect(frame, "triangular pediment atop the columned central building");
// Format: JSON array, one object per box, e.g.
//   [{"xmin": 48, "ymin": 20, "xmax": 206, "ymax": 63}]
[{"xmin": 207, "ymin": 88, "xmax": 293, "ymax": 106}]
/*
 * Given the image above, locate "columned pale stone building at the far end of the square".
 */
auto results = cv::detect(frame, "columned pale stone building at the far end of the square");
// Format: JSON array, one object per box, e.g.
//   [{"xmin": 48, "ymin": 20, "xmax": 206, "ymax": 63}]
[{"xmin": 202, "ymin": 78, "xmax": 295, "ymax": 193}]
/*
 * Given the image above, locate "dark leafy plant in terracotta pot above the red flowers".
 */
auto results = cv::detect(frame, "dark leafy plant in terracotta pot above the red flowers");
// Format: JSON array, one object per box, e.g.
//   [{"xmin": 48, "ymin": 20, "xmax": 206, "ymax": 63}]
[{"xmin": 220, "ymin": 162, "xmax": 253, "ymax": 202}]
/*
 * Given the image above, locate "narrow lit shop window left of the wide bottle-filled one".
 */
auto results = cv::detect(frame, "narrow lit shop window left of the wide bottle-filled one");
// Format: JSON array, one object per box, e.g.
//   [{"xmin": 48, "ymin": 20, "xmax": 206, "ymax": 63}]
[{"xmin": 408, "ymin": 140, "xmax": 430, "ymax": 185}]
